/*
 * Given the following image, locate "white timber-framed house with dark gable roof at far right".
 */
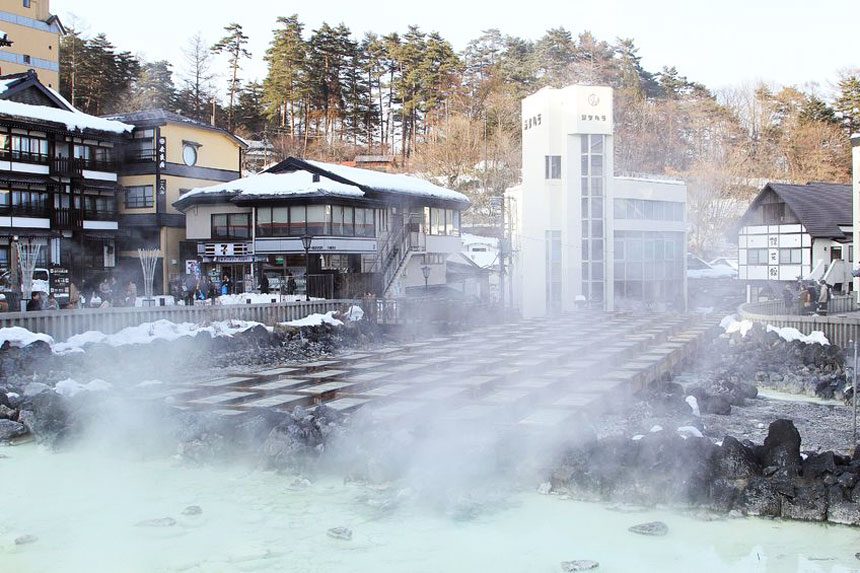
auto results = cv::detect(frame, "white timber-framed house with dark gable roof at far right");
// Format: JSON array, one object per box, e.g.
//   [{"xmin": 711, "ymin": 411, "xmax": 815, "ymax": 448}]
[{"xmin": 738, "ymin": 183, "xmax": 853, "ymax": 299}]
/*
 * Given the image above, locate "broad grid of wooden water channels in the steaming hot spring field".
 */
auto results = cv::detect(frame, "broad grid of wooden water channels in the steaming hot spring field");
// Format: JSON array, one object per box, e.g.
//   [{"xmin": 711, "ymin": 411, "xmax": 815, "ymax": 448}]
[{"xmin": 141, "ymin": 313, "xmax": 718, "ymax": 427}]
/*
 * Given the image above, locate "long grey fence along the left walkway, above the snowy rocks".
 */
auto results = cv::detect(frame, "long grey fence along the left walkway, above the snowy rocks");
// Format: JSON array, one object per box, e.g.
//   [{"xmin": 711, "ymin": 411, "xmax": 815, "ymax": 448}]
[{"xmin": 0, "ymin": 299, "xmax": 356, "ymax": 340}]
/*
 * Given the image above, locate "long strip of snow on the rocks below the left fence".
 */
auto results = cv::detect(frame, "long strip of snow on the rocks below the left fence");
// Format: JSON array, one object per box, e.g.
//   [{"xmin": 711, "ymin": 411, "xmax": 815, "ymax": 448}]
[{"xmin": 54, "ymin": 320, "xmax": 268, "ymax": 354}]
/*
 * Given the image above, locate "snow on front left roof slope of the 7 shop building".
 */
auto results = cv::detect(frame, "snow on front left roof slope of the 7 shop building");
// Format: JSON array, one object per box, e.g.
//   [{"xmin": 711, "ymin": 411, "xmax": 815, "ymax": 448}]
[{"xmin": 182, "ymin": 171, "xmax": 364, "ymax": 201}]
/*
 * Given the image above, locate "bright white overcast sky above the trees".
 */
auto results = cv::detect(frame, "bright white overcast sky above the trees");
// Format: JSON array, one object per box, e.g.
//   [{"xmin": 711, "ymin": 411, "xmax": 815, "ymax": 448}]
[{"xmin": 57, "ymin": 0, "xmax": 860, "ymax": 95}]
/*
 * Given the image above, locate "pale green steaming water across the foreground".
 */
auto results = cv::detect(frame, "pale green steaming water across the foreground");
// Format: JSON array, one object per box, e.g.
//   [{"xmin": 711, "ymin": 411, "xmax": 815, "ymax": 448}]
[{"xmin": 0, "ymin": 445, "xmax": 860, "ymax": 573}]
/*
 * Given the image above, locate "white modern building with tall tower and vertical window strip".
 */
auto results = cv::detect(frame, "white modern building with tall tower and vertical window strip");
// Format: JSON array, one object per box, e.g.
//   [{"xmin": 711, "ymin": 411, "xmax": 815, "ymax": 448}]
[{"xmin": 507, "ymin": 85, "xmax": 686, "ymax": 317}]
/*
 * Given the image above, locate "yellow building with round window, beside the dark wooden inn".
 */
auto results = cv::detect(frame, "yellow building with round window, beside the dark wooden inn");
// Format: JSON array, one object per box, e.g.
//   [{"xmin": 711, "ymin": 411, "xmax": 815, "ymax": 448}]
[{"xmin": 105, "ymin": 109, "xmax": 245, "ymax": 293}]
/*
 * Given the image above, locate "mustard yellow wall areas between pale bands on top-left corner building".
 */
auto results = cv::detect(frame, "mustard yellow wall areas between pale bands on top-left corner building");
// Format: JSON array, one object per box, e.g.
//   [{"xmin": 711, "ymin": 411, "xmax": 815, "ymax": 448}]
[{"xmin": 0, "ymin": 0, "xmax": 60, "ymax": 89}]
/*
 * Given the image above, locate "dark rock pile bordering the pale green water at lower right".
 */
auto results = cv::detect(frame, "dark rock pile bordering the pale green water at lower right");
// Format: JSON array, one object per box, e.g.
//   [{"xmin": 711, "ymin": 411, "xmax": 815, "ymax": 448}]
[{"xmin": 551, "ymin": 420, "xmax": 860, "ymax": 525}]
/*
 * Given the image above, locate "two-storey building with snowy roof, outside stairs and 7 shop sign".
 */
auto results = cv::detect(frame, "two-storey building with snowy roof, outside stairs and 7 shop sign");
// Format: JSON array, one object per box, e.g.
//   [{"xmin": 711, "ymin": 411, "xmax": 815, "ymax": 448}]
[{"xmin": 174, "ymin": 157, "xmax": 469, "ymax": 297}]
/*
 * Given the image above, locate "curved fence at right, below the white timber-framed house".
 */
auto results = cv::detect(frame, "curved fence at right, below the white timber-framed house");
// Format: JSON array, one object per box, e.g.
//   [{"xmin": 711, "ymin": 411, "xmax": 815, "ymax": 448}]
[{"xmin": 738, "ymin": 295, "xmax": 860, "ymax": 348}]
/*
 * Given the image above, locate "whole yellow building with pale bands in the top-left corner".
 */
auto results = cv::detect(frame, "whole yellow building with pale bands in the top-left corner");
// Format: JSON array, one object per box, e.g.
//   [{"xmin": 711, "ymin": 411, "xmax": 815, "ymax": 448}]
[{"xmin": 0, "ymin": 0, "xmax": 65, "ymax": 89}]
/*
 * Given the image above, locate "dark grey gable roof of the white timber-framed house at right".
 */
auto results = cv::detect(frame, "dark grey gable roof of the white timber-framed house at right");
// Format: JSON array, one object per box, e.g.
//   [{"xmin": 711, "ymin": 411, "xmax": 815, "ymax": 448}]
[{"xmin": 744, "ymin": 182, "xmax": 853, "ymax": 239}]
